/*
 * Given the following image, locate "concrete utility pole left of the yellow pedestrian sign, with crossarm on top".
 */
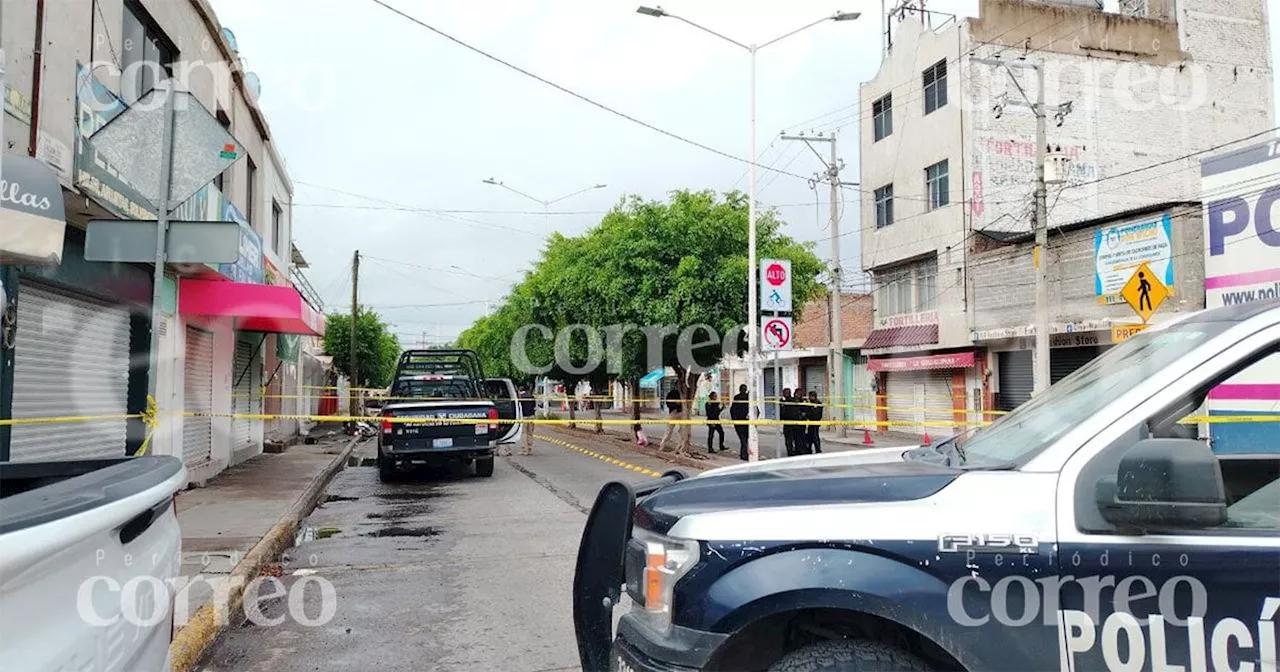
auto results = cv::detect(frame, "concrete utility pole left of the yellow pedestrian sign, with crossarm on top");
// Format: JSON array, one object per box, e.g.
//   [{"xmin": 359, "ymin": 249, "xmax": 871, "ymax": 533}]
[{"xmin": 973, "ymin": 58, "xmax": 1071, "ymax": 394}]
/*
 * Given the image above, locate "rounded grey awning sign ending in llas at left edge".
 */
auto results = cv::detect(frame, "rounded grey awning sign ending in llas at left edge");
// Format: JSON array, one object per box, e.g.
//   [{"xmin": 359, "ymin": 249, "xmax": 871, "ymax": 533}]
[{"xmin": 0, "ymin": 154, "xmax": 67, "ymax": 266}]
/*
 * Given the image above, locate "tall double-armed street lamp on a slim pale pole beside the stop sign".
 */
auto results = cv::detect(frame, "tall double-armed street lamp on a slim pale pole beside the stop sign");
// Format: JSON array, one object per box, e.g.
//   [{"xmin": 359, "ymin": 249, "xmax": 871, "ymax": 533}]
[{"xmin": 636, "ymin": 6, "xmax": 861, "ymax": 462}]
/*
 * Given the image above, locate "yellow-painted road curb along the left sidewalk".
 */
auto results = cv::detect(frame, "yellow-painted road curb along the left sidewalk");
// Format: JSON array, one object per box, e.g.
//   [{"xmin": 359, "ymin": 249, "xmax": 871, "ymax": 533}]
[{"xmin": 169, "ymin": 436, "xmax": 360, "ymax": 672}]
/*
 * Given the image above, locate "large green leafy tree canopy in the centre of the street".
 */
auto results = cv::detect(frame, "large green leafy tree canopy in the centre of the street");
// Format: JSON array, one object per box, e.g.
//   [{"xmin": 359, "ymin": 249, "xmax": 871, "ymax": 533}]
[{"xmin": 458, "ymin": 185, "xmax": 824, "ymax": 447}]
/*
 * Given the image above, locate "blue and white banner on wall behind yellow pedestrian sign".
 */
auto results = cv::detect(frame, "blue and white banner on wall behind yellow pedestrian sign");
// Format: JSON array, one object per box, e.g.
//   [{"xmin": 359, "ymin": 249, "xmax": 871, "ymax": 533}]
[{"xmin": 1093, "ymin": 212, "xmax": 1174, "ymax": 305}]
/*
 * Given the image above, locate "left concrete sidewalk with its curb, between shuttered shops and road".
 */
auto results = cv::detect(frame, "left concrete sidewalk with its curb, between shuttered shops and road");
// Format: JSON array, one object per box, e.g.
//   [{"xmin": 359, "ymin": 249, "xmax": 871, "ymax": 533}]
[{"xmin": 172, "ymin": 426, "xmax": 355, "ymax": 672}]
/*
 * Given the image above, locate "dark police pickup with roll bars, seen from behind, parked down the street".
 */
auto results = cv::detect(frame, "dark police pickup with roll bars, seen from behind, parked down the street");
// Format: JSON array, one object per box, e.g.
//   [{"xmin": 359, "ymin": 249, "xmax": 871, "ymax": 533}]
[{"xmin": 378, "ymin": 349, "xmax": 521, "ymax": 481}]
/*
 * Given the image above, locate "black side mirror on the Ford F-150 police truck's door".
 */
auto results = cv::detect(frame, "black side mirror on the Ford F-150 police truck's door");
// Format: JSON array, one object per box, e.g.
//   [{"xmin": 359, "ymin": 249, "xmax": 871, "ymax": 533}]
[{"xmin": 1096, "ymin": 439, "xmax": 1226, "ymax": 530}]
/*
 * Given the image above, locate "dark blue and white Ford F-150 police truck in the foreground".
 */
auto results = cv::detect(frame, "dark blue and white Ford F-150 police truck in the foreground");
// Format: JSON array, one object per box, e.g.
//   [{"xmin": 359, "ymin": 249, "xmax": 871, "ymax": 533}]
[{"xmin": 573, "ymin": 302, "xmax": 1280, "ymax": 672}]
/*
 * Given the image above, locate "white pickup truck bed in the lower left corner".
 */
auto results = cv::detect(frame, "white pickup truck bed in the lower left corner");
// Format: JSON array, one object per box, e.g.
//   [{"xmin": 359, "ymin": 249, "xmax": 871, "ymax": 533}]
[{"xmin": 0, "ymin": 456, "xmax": 187, "ymax": 672}]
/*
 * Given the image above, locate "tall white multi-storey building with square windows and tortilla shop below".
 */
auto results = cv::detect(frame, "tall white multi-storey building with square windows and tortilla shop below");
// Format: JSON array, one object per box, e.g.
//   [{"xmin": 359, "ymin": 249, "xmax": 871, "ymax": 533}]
[{"xmin": 860, "ymin": 0, "xmax": 1274, "ymax": 433}]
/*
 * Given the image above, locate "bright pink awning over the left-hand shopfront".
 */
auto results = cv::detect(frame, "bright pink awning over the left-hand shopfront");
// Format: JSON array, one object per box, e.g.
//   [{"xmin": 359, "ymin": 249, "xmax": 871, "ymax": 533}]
[{"xmin": 178, "ymin": 278, "xmax": 324, "ymax": 335}]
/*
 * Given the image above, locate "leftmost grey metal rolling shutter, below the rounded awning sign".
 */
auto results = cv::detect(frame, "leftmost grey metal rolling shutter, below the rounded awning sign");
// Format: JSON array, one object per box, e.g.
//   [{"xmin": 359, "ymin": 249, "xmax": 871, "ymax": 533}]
[{"xmin": 9, "ymin": 284, "xmax": 129, "ymax": 462}]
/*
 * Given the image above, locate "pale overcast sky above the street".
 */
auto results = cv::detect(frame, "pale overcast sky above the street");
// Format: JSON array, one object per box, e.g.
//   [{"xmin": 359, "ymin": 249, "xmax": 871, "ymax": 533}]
[{"xmin": 204, "ymin": 0, "xmax": 1280, "ymax": 346}]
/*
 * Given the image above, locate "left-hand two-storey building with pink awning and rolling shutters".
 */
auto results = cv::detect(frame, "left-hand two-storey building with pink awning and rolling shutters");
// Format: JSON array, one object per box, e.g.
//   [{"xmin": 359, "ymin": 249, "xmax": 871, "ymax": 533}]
[{"xmin": 0, "ymin": 0, "xmax": 323, "ymax": 481}]
